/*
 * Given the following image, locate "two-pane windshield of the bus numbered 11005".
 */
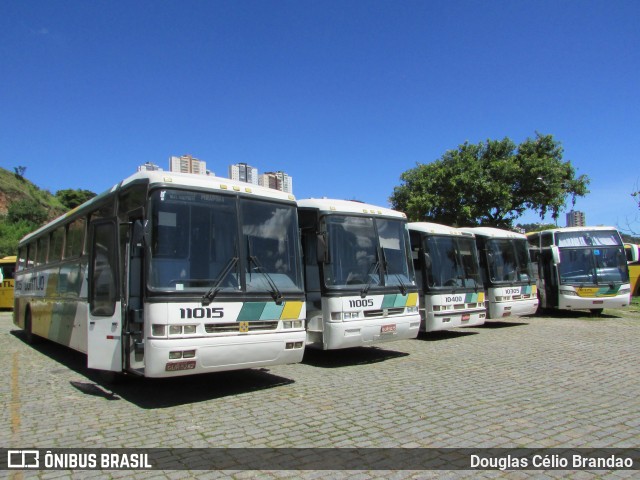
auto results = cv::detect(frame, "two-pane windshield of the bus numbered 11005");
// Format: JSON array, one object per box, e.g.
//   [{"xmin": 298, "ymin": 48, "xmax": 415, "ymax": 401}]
[{"xmin": 325, "ymin": 215, "xmax": 415, "ymax": 293}]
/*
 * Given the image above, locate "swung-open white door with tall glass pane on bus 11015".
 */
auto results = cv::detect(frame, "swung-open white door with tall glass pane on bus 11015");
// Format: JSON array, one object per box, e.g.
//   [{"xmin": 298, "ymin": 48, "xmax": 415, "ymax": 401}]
[{"xmin": 87, "ymin": 218, "xmax": 123, "ymax": 372}]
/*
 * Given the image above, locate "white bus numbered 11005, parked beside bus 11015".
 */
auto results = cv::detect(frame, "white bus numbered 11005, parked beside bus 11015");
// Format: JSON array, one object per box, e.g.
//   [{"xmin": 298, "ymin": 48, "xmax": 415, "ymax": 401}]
[{"xmin": 298, "ymin": 199, "xmax": 420, "ymax": 350}]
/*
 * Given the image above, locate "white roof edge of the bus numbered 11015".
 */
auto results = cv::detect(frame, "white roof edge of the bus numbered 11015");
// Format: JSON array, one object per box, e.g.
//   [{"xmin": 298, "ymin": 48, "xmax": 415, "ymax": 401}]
[{"xmin": 20, "ymin": 170, "xmax": 295, "ymax": 245}]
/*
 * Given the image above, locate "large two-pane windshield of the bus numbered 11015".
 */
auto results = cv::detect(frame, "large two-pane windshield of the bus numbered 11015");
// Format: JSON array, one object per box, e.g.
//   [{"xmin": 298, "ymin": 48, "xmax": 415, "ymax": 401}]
[{"xmin": 148, "ymin": 190, "xmax": 303, "ymax": 298}]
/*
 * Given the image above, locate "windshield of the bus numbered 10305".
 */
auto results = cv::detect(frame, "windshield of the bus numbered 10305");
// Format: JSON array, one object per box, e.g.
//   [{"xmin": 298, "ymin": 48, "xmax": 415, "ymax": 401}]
[{"xmin": 486, "ymin": 238, "xmax": 533, "ymax": 284}]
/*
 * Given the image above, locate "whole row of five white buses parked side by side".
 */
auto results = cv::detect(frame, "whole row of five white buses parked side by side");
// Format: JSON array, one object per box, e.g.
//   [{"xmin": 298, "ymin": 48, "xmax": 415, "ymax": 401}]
[{"xmin": 8, "ymin": 172, "xmax": 637, "ymax": 377}]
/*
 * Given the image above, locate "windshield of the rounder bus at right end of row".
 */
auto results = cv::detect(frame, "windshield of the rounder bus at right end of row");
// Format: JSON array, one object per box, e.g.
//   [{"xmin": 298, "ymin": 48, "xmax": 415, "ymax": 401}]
[{"xmin": 556, "ymin": 231, "xmax": 629, "ymax": 285}]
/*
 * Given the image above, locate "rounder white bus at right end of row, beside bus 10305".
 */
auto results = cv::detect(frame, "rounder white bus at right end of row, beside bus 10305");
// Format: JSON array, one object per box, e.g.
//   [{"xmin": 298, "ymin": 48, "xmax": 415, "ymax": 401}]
[{"xmin": 527, "ymin": 227, "xmax": 631, "ymax": 315}]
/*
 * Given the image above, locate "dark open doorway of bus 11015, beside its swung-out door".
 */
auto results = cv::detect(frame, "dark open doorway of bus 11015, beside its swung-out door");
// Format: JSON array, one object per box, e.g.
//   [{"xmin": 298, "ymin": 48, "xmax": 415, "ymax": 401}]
[{"xmin": 123, "ymin": 216, "xmax": 144, "ymax": 374}]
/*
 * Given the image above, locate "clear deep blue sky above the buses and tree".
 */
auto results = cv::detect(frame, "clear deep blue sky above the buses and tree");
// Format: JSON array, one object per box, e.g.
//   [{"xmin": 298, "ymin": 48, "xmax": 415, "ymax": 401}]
[{"xmin": 0, "ymin": 0, "xmax": 640, "ymax": 231}]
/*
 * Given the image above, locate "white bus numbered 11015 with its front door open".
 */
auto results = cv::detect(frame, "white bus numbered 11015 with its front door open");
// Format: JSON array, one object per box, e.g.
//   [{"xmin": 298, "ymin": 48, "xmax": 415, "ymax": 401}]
[{"xmin": 14, "ymin": 172, "xmax": 306, "ymax": 377}]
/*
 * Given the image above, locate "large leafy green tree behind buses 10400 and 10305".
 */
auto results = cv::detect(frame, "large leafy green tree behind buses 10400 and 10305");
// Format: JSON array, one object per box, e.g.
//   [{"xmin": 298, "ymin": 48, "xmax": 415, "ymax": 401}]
[{"xmin": 390, "ymin": 133, "xmax": 589, "ymax": 228}]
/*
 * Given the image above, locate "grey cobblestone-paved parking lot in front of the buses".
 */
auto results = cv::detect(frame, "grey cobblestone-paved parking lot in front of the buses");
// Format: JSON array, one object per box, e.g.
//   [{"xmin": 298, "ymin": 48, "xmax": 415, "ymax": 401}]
[{"xmin": 0, "ymin": 307, "xmax": 640, "ymax": 478}]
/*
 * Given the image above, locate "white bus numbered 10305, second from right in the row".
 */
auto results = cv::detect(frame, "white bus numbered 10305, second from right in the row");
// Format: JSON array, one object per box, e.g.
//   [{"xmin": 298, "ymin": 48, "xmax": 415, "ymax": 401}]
[{"xmin": 461, "ymin": 227, "xmax": 538, "ymax": 319}]
